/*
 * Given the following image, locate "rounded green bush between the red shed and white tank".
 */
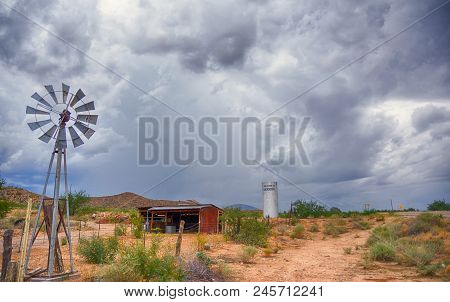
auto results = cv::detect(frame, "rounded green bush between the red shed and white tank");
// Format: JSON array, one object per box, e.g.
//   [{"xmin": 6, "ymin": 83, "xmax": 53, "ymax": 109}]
[{"xmin": 236, "ymin": 218, "xmax": 270, "ymax": 246}]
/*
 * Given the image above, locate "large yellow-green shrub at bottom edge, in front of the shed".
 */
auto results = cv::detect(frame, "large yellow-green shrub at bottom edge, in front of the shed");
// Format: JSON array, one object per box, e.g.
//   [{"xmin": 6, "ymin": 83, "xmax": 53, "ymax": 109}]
[{"xmin": 101, "ymin": 244, "xmax": 185, "ymax": 282}]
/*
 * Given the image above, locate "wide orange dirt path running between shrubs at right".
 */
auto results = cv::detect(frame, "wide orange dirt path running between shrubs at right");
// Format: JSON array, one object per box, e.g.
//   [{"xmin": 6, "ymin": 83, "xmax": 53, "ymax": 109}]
[{"xmin": 214, "ymin": 231, "xmax": 434, "ymax": 282}]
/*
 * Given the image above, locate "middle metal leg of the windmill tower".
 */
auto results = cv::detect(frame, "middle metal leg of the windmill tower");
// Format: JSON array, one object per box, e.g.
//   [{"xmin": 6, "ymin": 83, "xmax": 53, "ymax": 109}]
[{"xmin": 48, "ymin": 148, "xmax": 62, "ymax": 277}]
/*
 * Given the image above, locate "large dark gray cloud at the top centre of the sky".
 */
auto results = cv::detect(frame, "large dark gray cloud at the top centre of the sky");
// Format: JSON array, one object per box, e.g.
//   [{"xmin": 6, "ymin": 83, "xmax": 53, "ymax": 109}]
[{"xmin": 131, "ymin": 4, "xmax": 256, "ymax": 72}]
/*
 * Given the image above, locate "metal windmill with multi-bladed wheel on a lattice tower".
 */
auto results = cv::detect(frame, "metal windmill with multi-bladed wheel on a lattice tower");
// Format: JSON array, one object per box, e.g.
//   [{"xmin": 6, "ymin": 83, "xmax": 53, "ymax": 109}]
[{"xmin": 24, "ymin": 83, "xmax": 98, "ymax": 279}]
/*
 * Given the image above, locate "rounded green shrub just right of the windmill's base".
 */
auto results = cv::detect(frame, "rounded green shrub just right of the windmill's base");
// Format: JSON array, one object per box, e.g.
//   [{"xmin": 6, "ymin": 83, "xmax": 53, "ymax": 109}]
[{"xmin": 78, "ymin": 236, "xmax": 119, "ymax": 264}]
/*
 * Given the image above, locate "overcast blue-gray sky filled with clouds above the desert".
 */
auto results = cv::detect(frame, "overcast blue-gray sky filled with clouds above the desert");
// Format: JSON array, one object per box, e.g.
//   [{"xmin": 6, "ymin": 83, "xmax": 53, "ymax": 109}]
[{"xmin": 0, "ymin": 0, "xmax": 450, "ymax": 210}]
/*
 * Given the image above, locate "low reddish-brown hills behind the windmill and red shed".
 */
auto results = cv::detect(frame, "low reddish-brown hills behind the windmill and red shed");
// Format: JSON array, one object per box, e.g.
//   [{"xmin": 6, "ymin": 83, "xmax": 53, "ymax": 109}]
[{"xmin": 0, "ymin": 187, "xmax": 199, "ymax": 208}]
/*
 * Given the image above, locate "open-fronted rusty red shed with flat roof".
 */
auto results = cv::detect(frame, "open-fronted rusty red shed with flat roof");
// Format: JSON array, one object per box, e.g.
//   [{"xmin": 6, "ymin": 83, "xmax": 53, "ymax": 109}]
[{"xmin": 138, "ymin": 204, "xmax": 223, "ymax": 233}]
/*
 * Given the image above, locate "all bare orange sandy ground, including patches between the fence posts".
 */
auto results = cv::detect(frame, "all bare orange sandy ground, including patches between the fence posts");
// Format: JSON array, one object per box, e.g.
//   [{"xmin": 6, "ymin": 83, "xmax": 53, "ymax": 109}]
[{"xmin": 0, "ymin": 219, "xmax": 439, "ymax": 281}]
